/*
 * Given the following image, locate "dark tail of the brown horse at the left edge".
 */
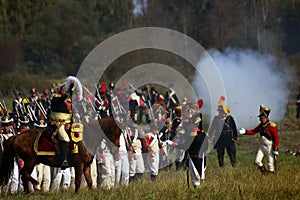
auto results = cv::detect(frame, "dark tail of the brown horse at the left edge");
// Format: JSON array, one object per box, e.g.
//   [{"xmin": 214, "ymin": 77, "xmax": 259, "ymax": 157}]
[{"xmin": 0, "ymin": 136, "xmax": 16, "ymax": 185}]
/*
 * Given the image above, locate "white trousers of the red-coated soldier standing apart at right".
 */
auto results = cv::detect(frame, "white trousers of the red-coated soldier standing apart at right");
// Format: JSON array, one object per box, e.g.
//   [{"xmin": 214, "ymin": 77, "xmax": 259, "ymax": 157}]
[{"xmin": 255, "ymin": 136, "xmax": 275, "ymax": 172}]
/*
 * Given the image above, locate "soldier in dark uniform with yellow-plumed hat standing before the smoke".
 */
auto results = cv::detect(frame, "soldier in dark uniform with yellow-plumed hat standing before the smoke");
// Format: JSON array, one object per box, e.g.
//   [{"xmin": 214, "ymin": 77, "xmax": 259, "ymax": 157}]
[{"xmin": 209, "ymin": 96, "xmax": 238, "ymax": 167}]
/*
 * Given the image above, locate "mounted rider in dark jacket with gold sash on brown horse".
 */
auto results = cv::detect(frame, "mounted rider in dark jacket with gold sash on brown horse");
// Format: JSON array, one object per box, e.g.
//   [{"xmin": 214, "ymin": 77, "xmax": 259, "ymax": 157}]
[{"xmin": 50, "ymin": 85, "xmax": 72, "ymax": 167}]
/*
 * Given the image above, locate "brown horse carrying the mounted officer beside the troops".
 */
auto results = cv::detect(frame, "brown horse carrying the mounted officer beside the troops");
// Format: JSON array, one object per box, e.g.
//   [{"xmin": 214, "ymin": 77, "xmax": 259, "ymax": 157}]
[{"xmin": 0, "ymin": 119, "xmax": 121, "ymax": 193}]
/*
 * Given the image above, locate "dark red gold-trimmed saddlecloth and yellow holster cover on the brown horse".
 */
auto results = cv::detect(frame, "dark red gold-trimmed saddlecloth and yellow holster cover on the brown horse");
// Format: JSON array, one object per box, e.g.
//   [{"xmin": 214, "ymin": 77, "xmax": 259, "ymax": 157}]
[{"xmin": 34, "ymin": 125, "xmax": 82, "ymax": 156}]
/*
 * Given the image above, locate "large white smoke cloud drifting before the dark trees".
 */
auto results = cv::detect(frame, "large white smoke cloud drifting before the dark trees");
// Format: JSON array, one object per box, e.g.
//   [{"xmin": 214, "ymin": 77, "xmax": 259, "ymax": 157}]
[{"xmin": 193, "ymin": 48, "xmax": 292, "ymax": 128}]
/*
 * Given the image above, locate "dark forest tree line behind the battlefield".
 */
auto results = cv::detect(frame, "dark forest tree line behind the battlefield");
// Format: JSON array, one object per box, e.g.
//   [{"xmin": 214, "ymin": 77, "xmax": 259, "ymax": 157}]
[{"xmin": 0, "ymin": 0, "xmax": 300, "ymax": 93}]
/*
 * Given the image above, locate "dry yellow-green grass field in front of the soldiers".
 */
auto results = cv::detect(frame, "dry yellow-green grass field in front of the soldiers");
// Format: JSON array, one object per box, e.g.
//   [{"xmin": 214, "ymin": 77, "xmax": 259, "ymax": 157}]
[{"xmin": 0, "ymin": 120, "xmax": 300, "ymax": 200}]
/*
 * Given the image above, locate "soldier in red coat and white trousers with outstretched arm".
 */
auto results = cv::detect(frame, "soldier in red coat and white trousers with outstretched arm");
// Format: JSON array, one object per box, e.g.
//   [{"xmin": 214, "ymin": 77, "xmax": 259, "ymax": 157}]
[{"xmin": 239, "ymin": 105, "xmax": 279, "ymax": 174}]
